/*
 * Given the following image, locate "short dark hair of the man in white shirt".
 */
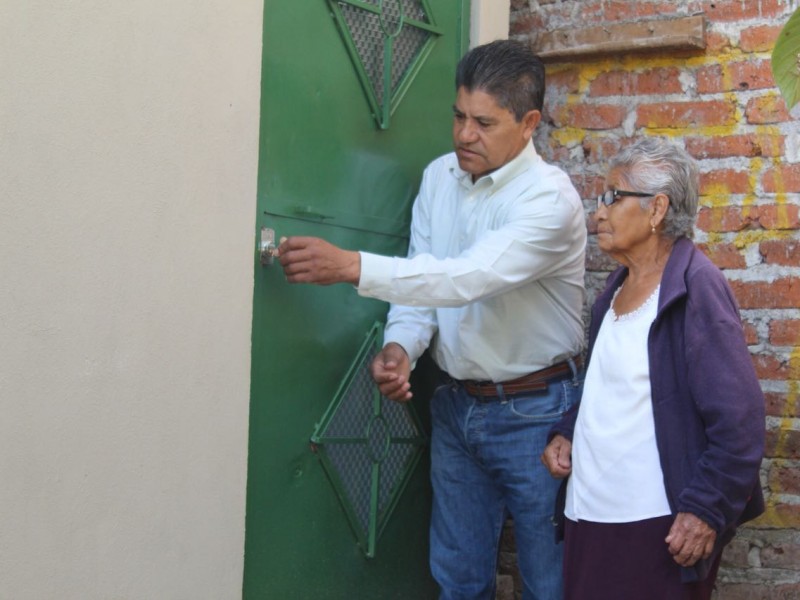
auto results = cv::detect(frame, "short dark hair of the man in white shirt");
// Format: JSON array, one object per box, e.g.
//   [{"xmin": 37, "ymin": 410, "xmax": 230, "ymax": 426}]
[{"xmin": 456, "ymin": 40, "xmax": 544, "ymax": 122}]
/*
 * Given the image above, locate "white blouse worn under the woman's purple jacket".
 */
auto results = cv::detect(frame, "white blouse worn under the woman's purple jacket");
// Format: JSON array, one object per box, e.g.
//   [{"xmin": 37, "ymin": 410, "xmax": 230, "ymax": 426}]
[{"xmin": 565, "ymin": 286, "xmax": 670, "ymax": 523}]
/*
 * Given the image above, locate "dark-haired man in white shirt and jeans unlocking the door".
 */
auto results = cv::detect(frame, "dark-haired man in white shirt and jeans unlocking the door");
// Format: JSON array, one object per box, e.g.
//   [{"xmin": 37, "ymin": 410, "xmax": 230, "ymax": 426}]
[{"xmin": 279, "ymin": 41, "xmax": 586, "ymax": 600}]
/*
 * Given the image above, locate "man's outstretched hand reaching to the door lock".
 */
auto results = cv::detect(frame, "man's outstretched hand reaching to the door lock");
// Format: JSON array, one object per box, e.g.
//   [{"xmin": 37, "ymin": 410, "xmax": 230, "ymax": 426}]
[{"xmin": 278, "ymin": 237, "xmax": 361, "ymax": 285}]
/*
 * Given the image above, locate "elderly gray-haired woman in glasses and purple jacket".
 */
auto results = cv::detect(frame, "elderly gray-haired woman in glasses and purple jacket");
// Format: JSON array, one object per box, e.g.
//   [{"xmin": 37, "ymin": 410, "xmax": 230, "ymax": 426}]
[{"xmin": 542, "ymin": 139, "xmax": 764, "ymax": 600}]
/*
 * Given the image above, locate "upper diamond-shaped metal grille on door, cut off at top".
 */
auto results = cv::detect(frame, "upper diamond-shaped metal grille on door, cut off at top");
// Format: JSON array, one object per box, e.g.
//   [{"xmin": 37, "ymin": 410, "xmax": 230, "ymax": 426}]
[{"xmin": 328, "ymin": 0, "xmax": 441, "ymax": 129}]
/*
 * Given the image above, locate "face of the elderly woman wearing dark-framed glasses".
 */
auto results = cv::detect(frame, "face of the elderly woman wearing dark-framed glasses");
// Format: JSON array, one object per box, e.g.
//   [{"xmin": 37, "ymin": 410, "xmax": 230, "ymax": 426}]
[{"xmin": 593, "ymin": 169, "xmax": 652, "ymax": 262}]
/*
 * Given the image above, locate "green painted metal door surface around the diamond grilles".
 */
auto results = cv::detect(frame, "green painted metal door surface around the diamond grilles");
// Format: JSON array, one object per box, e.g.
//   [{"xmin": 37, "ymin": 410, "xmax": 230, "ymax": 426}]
[{"xmin": 243, "ymin": 0, "xmax": 469, "ymax": 600}]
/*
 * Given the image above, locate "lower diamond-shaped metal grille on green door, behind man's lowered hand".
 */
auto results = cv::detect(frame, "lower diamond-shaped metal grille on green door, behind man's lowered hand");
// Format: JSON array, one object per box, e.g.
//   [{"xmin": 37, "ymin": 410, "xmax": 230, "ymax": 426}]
[{"xmin": 311, "ymin": 324, "xmax": 427, "ymax": 557}]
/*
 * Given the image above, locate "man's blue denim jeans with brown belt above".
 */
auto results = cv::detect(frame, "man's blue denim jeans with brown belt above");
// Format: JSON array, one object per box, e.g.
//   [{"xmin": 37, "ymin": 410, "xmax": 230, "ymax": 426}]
[{"xmin": 430, "ymin": 377, "xmax": 581, "ymax": 600}]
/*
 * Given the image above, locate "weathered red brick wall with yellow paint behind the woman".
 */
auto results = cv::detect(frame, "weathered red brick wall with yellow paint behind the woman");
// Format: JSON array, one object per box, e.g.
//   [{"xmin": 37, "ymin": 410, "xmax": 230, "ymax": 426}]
[{"xmin": 510, "ymin": 0, "xmax": 800, "ymax": 599}]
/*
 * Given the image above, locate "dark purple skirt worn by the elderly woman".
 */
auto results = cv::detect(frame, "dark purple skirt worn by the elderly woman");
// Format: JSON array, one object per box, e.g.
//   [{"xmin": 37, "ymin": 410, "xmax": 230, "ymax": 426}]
[{"xmin": 564, "ymin": 515, "xmax": 720, "ymax": 600}]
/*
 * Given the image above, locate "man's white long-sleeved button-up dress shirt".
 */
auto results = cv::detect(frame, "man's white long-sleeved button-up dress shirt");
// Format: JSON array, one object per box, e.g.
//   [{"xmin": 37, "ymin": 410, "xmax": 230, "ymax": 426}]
[{"xmin": 358, "ymin": 143, "xmax": 586, "ymax": 382}]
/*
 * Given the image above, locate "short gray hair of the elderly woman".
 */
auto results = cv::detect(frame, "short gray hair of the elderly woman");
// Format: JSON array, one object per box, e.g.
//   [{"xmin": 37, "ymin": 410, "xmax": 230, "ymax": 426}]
[{"xmin": 609, "ymin": 138, "xmax": 699, "ymax": 239}]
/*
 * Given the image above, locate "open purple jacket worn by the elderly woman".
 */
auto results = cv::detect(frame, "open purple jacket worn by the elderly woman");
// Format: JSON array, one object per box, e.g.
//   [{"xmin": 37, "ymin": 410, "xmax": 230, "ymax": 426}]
[{"xmin": 550, "ymin": 238, "xmax": 765, "ymax": 582}]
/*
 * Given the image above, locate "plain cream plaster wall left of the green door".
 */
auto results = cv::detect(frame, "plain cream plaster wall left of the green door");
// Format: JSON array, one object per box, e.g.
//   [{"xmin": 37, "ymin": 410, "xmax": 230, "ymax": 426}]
[{"xmin": 0, "ymin": 0, "xmax": 262, "ymax": 600}]
